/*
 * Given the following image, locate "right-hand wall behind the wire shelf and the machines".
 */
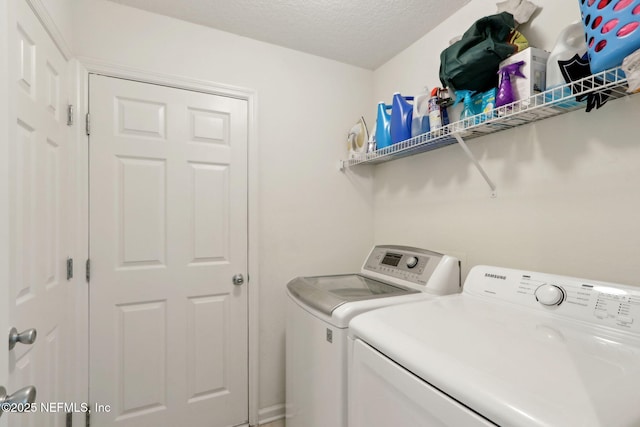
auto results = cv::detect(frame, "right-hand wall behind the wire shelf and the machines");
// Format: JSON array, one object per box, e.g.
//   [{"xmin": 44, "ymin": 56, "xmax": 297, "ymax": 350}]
[{"xmin": 374, "ymin": 0, "xmax": 640, "ymax": 285}]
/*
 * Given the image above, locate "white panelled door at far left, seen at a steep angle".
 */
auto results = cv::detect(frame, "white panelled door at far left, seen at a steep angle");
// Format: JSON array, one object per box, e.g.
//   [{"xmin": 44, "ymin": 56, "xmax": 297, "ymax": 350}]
[{"xmin": 2, "ymin": 0, "xmax": 73, "ymax": 427}]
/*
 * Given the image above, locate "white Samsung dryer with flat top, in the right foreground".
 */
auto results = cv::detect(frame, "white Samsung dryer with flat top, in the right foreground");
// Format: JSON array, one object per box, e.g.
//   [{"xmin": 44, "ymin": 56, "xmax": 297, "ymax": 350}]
[{"xmin": 349, "ymin": 266, "xmax": 640, "ymax": 427}]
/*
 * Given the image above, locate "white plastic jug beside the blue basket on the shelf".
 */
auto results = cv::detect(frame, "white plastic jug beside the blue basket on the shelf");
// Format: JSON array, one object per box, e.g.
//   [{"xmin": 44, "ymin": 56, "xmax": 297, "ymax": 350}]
[{"xmin": 547, "ymin": 21, "xmax": 587, "ymax": 90}]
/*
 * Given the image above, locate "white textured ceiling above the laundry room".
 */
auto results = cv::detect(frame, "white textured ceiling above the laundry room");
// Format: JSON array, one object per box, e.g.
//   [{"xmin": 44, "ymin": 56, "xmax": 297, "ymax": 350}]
[{"xmin": 107, "ymin": 0, "xmax": 470, "ymax": 69}]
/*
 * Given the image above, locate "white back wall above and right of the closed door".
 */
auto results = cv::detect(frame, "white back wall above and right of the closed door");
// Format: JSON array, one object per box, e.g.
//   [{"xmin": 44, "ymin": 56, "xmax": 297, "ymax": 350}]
[{"xmin": 73, "ymin": 0, "xmax": 373, "ymax": 412}]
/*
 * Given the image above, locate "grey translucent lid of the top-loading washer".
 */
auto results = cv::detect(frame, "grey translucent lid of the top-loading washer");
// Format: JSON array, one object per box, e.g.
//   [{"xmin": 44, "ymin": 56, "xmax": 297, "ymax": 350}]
[{"xmin": 287, "ymin": 274, "xmax": 419, "ymax": 315}]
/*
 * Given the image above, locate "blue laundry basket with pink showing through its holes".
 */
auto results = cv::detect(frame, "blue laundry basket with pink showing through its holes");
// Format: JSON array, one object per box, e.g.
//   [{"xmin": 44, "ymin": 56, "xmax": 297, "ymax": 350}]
[{"xmin": 579, "ymin": 0, "xmax": 640, "ymax": 74}]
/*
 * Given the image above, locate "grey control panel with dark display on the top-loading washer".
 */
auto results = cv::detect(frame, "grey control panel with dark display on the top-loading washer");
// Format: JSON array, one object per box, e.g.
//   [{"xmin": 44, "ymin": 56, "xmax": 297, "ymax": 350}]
[{"xmin": 362, "ymin": 245, "xmax": 444, "ymax": 286}]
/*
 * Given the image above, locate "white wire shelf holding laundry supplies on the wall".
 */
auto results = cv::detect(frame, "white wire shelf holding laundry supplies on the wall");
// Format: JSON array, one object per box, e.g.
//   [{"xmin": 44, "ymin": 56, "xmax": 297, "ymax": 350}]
[{"xmin": 341, "ymin": 68, "xmax": 630, "ymax": 168}]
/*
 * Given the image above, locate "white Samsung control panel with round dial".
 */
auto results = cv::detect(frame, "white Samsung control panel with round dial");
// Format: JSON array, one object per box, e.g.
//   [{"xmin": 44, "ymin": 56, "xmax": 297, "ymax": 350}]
[{"xmin": 463, "ymin": 266, "xmax": 640, "ymax": 333}]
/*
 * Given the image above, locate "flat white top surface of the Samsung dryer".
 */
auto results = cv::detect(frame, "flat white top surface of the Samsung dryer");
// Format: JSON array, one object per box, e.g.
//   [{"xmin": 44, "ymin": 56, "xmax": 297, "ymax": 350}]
[{"xmin": 349, "ymin": 294, "xmax": 640, "ymax": 427}]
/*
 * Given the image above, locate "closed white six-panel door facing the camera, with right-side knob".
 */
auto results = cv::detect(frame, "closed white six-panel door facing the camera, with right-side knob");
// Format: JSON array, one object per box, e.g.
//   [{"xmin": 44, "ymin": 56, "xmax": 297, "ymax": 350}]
[{"xmin": 89, "ymin": 74, "xmax": 248, "ymax": 427}]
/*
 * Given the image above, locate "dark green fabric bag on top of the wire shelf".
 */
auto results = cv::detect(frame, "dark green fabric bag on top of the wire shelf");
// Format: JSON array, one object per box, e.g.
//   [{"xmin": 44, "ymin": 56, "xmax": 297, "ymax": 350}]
[{"xmin": 440, "ymin": 12, "xmax": 529, "ymax": 92}]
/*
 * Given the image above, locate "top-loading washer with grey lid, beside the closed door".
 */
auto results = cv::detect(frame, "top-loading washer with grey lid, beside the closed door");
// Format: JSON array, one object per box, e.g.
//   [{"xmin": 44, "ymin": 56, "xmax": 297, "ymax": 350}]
[{"xmin": 286, "ymin": 246, "xmax": 461, "ymax": 427}]
